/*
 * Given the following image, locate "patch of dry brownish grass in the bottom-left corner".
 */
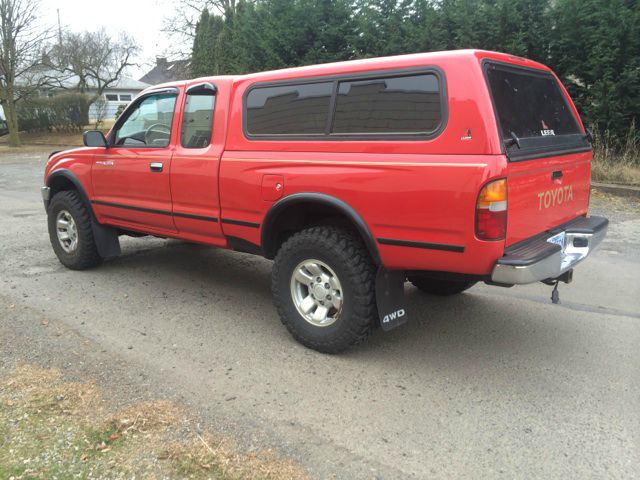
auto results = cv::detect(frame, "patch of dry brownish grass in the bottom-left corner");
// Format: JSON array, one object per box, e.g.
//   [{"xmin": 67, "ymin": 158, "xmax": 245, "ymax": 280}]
[{"xmin": 0, "ymin": 365, "xmax": 307, "ymax": 480}]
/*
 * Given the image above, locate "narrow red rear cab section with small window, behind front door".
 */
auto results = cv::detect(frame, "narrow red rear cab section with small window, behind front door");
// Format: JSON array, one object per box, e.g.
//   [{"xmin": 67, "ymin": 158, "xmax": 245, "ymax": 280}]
[{"xmin": 171, "ymin": 82, "xmax": 228, "ymax": 246}]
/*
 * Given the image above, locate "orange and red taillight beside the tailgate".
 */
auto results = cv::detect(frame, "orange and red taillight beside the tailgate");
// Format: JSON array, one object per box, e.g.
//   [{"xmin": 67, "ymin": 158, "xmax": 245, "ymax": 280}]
[{"xmin": 476, "ymin": 178, "xmax": 507, "ymax": 240}]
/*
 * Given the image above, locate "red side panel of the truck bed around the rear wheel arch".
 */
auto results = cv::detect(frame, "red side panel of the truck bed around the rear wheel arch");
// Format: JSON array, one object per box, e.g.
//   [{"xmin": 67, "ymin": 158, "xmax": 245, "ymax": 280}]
[{"xmin": 220, "ymin": 152, "xmax": 506, "ymax": 274}]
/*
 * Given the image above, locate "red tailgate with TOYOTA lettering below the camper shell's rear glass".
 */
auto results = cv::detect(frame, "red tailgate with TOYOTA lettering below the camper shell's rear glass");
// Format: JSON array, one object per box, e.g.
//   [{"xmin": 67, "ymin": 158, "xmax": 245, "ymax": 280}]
[{"xmin": 506, "ymin": 152, "xmax": 591, "ymax": 246}]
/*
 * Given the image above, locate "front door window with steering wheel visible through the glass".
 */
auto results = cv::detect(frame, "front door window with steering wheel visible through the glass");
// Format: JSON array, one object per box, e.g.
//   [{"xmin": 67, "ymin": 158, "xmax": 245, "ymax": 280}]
[{"xmin": 114, "ymin": 93, "xmax": 176, "ymax": 148}]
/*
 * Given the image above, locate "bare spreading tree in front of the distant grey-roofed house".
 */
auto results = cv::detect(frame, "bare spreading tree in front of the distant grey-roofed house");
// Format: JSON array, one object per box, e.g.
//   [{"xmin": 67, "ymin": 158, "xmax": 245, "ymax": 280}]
[{"xmin": 47, "ymin": 29, "xmax": 139, "ymax": 125}]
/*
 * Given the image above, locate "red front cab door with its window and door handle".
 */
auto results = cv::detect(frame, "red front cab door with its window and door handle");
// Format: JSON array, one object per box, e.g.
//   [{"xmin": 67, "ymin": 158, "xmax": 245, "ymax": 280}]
[{"xmin": 91, "ymin": 88, "xmax": 179, "ymax": 232}]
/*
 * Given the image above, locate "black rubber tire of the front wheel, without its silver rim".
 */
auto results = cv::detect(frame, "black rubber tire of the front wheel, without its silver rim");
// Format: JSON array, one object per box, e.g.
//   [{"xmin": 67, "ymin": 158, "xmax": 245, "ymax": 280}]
[{"xmin": 47, "ymin": 190, "xmax": 103, "ymax": 270}]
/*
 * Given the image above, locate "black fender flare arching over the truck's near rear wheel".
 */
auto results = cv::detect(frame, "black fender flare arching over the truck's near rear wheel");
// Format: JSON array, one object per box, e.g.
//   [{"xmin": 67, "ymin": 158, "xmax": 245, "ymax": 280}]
[{"xmin": 260, "ymin": 192, "xmax": 382, "ymax": 265}]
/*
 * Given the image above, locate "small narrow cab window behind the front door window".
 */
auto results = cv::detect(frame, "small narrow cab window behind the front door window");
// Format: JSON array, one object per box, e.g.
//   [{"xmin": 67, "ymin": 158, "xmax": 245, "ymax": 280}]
[{"xmin": 180, "ymin": 90, "xmax": 216, "ymax": 148}]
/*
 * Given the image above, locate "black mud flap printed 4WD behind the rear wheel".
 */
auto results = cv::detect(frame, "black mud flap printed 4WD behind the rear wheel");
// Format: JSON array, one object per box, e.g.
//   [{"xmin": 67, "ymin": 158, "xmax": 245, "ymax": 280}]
[{"xmin": 376, "ymin": 267, "xmax": 407, "ymax": 331}]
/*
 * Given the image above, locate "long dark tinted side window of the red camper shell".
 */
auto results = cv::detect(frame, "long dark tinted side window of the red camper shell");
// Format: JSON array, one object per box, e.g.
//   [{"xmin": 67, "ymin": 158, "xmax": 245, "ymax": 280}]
[{"xmin": 244, "ymin": 67, "xmax": 446, "ymax": 140}]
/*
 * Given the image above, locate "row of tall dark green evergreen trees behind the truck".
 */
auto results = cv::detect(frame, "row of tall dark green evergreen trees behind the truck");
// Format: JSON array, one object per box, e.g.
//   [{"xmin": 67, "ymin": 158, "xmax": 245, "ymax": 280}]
[{"xmin": 192, "ymin": 0, "xmax": 640, "ymax": 147}]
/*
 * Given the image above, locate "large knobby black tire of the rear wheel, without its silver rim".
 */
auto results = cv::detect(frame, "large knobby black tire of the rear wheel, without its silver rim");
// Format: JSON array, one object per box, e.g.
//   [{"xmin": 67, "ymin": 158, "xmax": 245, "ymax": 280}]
[{"xmin": 271, "ymin": 226, "xmax": 378, "ymax": 353}]
